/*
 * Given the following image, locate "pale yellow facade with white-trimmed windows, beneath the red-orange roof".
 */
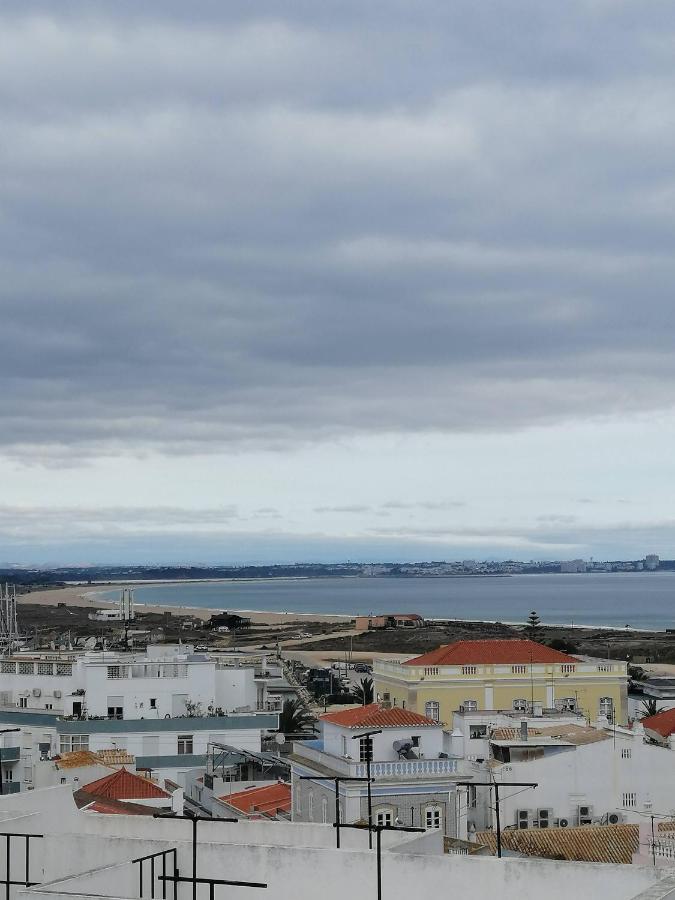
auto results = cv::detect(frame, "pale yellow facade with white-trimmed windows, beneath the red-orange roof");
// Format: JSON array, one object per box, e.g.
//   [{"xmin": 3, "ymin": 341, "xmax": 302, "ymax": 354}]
[{"xmin": 373, "ymin": 661, "xmax": 628, "ymax": 725}]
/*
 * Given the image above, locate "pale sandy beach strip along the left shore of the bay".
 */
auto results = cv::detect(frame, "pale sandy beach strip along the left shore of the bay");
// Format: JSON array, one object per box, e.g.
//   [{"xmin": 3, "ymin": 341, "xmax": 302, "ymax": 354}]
[{"xmin": 17, "ymin": 585, "xmax": 351, "ymax": 625}]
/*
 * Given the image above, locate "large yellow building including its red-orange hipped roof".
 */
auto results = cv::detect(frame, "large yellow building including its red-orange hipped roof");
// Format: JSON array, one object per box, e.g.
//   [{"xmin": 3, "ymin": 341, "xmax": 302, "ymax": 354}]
[{"xmin": 373, "ymin": 640, "xmax": 628, "ymax": 725}]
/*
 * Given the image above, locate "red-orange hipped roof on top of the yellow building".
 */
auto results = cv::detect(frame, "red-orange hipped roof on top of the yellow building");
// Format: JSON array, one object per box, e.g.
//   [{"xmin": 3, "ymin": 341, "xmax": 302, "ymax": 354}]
[{"xmin": 404, "ymin": 638, "xmax": 578, "ymax": 666}]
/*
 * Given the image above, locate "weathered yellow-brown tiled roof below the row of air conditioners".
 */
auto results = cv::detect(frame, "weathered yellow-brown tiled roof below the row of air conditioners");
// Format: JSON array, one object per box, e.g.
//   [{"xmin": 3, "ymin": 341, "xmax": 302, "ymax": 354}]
[{"xmin": 476, "ymin": 825, "xmax": 639, "ymax": 865}]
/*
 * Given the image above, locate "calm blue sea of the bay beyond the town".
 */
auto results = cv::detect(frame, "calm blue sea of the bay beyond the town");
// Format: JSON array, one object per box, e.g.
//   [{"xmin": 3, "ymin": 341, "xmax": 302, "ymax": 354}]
[{"xmin": 92, "ymin": 572, "xmax": 675, "ymax": 630}]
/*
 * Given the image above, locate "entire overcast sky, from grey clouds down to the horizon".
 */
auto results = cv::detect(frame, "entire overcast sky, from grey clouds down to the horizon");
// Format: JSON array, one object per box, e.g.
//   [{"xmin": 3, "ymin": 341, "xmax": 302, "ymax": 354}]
[{"xmin": 0, "ymin": 0, "xmax": 675, "ymax": 563}]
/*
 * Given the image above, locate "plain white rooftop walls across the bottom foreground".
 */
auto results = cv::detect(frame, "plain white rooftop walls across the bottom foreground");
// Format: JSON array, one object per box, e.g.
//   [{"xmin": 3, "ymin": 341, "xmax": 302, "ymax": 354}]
[{"xmin": 0, "ymin": 787, "xmax": 675, "ymax": 900}]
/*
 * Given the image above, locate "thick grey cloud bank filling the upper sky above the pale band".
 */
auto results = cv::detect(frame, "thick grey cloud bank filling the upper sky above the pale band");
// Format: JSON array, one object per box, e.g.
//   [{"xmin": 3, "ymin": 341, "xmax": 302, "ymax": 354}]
[{"xmin": 0, "ymin": 2, "xmax": 675, "ymax": 458}]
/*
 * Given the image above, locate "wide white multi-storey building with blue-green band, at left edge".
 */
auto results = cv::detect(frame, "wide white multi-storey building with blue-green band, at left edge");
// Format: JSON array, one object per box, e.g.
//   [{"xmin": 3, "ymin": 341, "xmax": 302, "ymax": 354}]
[{"xmin": 0, "ymin": 645, "xmax": 283, "ymax": 791}]
